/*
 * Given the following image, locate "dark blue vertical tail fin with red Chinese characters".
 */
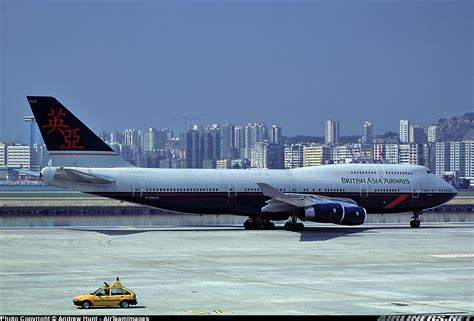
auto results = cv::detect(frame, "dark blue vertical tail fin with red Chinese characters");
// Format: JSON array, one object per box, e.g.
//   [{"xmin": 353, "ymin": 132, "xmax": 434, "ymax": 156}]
[{"xmin": 27, "ymin": 96, "xmax": 132, "ymax": 167}]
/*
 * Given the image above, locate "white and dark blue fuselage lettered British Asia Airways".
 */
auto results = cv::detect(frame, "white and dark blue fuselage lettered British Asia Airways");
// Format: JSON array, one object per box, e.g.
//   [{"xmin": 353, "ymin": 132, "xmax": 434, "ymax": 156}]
[{"xmin": 42, "ymin": 164, "xmax": 456, "ymax": 215}]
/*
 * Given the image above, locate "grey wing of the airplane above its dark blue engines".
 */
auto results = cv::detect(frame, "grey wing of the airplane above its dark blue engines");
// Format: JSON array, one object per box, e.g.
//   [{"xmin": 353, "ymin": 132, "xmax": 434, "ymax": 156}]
[{"xmin": 257, "ymin": 183, "xmax": 358, "ymax": 212}]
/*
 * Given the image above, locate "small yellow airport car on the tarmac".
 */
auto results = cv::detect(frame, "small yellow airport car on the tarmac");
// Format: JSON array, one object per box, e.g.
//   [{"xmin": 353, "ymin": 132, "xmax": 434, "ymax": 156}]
[{"xmin": 72, "ymin": 278, "xmax": 138, "ymax": 309}]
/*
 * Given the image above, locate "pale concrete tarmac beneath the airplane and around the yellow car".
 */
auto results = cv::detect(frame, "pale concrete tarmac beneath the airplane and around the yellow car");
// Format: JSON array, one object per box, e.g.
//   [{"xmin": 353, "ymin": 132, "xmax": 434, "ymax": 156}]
[{"xmin": 0, "ymin": 223, "xmax": 474, "ymax": 315}]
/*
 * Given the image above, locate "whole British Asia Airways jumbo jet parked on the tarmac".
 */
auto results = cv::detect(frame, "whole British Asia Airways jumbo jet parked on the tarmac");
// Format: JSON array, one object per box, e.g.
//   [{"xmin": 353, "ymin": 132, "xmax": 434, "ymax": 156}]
[{"xmin": 27, "ymin": 96, "xmax": 457, "ymax": 231}]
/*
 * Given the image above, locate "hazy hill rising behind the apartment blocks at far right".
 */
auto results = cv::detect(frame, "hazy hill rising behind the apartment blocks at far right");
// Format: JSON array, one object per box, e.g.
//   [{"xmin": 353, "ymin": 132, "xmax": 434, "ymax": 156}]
[{"xmin": 433, "ymin": 113, "xmax": 474, "ymax": 142}]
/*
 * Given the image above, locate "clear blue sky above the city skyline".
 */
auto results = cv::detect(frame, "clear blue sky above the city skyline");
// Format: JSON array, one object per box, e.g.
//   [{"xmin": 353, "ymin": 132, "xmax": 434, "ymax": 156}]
[{"xmin": 0, "ymin": 0, "xmax": 474, "ymax": 142}]
